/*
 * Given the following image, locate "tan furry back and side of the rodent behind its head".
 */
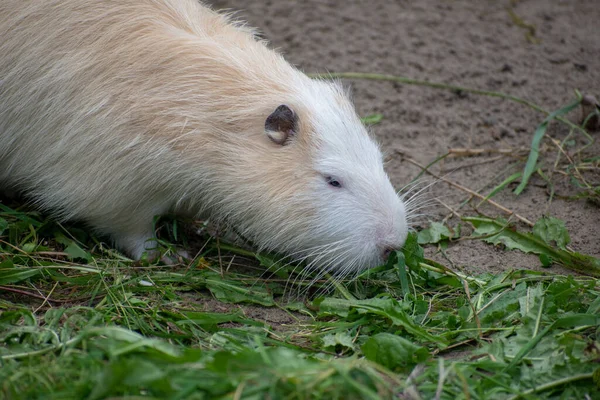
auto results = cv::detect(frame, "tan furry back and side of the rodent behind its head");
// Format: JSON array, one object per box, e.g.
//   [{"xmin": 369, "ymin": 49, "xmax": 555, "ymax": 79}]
[{"xmin": 0, "ymin": 0, "xmax": 310, "ymax": 221}]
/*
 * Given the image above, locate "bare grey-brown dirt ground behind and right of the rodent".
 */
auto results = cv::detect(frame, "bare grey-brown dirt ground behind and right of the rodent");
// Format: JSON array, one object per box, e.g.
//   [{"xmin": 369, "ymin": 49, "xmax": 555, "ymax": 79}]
[{"xmin": 209, "ymin": 0, "xmax": 600, "ymax": 272}]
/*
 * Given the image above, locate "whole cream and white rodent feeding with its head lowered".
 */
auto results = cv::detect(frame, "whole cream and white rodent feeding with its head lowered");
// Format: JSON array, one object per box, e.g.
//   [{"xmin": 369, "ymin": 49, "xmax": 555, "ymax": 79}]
[{"xmin": 0, "ymin": 0, "xmax": 407, "ymax": 276}]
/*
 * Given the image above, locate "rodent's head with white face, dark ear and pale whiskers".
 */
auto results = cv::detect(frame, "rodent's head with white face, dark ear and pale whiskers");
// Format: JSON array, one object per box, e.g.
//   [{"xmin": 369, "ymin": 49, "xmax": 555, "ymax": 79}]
[{"xmin": 225, "ymin": 81, "xmax": 408, "ymax": 277}]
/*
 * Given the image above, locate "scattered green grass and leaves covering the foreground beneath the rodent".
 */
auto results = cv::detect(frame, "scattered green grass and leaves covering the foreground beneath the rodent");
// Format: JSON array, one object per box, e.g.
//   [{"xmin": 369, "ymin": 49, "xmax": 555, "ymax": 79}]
[{"xmin": 0, "ymin": 205, "xmax": 600, "ymax": 399}]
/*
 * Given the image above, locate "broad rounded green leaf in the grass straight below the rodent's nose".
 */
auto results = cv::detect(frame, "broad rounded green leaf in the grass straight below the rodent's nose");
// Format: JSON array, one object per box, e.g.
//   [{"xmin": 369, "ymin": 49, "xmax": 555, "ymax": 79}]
[{"xmin": 361, "ymin": 333, "xmax": 429, "ymax": 371}]
